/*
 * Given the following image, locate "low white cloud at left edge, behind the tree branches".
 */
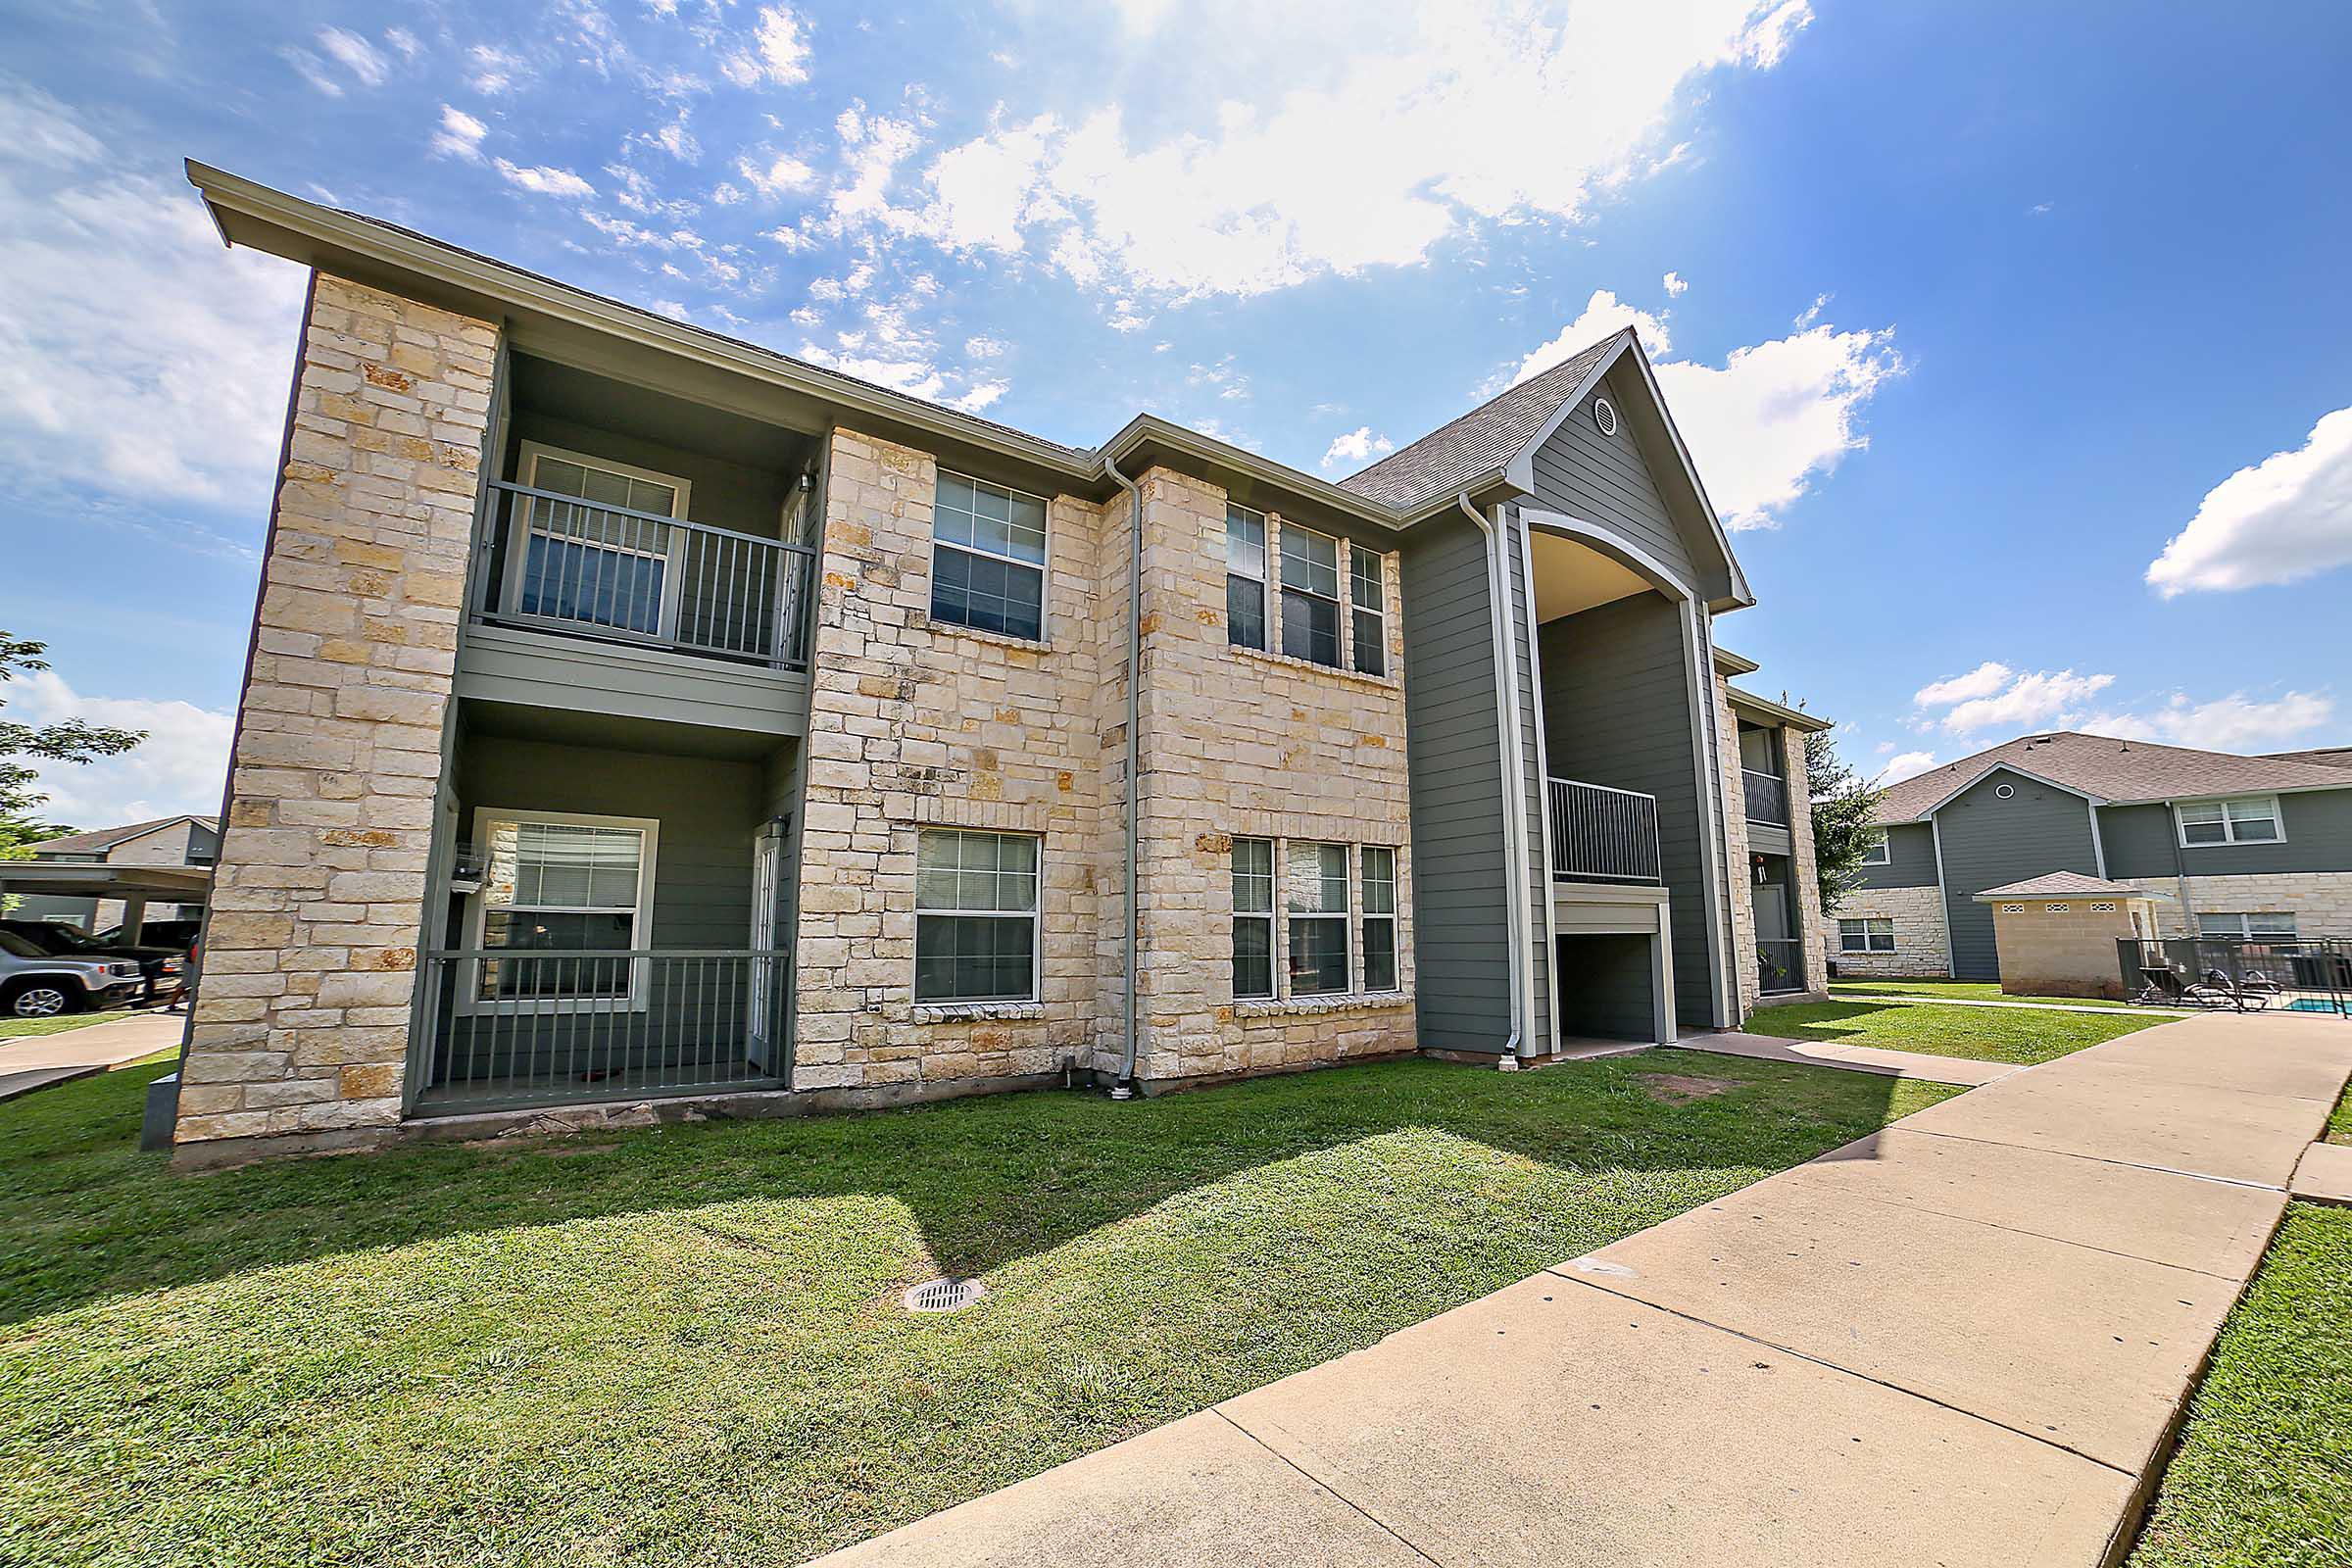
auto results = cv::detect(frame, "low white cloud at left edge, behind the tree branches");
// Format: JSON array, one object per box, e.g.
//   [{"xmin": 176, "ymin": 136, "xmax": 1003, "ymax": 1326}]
[{"xmin": 7, "ymin": 670, "xmax": 235, "ymax": 827}]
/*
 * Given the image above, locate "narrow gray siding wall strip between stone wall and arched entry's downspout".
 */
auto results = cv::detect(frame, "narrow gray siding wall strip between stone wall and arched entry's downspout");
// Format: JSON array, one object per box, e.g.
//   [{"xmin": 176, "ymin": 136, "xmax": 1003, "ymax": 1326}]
[{"xmin": 1401, "ymin": 517, "xmax": 1510, "ymax": 1051}]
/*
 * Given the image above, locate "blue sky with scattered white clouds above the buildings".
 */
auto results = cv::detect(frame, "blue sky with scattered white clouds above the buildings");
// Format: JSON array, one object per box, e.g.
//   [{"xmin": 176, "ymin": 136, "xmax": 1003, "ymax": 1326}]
[{"xmin": 0, "ymin": 0, "xmax": 2352, "ymax": 825}]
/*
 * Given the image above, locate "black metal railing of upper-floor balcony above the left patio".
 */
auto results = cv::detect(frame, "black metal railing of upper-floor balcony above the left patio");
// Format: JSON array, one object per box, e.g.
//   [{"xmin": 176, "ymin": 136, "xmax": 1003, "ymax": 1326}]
[{"xmin": 472, "ymin": 479, "xmax": 816, "ymax": 670}]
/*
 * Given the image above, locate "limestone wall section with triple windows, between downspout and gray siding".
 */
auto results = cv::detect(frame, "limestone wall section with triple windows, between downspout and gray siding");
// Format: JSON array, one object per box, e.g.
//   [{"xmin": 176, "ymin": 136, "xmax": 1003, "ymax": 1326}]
[{"xmin": 1136, "ymin": 470, "xmax": 1416, "ymax": 1081}]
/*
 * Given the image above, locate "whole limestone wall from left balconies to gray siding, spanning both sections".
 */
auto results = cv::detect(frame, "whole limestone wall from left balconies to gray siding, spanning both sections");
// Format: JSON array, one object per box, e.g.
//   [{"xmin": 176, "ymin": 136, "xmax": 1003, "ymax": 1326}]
[{"xmin": 793, "ymin": 430, "xmax": 1413, "ymax": 1089}]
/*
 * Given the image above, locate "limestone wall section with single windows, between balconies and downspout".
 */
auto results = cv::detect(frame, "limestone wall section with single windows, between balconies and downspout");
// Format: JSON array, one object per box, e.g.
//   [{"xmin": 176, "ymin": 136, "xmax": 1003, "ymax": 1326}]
[{"xmin": 793, "ymin": 430, "xmax": 1127, "ymax": 1089}]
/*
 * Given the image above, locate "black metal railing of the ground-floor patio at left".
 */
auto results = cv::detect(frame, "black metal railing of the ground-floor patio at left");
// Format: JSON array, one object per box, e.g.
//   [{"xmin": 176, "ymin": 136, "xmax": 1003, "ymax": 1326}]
[{"xmin": 418, "ymin": 948, "xmax": 790, "ymax": 1112}]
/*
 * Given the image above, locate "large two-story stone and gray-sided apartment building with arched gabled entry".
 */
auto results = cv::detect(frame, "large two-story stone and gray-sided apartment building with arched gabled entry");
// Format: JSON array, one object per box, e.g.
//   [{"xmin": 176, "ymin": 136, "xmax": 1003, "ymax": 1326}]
[{"xmin": 176, "ymin": 165, "xmax": 1828, "ymax": 1148}]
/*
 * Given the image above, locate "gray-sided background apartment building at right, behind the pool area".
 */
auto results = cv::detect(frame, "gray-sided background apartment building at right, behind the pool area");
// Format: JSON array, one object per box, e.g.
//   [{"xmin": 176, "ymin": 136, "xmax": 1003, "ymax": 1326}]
[{"xmin": 1837, "ymin": 731, "xmax": 2352, "ymax": 980}]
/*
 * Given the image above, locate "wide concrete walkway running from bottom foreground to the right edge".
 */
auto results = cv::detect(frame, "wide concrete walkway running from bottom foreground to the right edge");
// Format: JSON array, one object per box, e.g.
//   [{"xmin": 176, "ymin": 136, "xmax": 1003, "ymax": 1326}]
[{"xmin": 821, "ymin": 1018, "xmax": 2352, "ymax": 1568}]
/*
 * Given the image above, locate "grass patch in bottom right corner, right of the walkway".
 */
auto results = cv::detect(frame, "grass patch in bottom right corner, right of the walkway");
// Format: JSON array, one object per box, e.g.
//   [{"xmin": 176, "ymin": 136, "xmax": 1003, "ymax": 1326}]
[{"xmin": 2131, "ymin": 1203, "xmax": 2352, "ymax": 1568}]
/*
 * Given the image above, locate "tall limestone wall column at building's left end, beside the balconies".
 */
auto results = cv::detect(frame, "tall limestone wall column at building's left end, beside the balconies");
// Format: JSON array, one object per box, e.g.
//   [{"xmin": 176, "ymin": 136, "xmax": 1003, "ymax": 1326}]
[{"xmin": 176, "ymin": 275, "xmax": 499, "ymax": 1143}]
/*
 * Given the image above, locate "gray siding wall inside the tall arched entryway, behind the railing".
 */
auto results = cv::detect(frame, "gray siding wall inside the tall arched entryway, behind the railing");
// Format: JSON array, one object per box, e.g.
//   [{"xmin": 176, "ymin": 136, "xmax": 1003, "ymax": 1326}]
[{"xmin": 1541, "ymin": 592, "xmax": 1715, "ymax": 1022}]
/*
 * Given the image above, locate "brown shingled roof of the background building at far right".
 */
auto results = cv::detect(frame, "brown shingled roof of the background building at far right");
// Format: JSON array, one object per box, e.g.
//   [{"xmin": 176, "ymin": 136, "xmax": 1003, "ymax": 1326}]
[{"xmin": 1875, "ymin": 729, "xmax": 2352, "ymax": 825}]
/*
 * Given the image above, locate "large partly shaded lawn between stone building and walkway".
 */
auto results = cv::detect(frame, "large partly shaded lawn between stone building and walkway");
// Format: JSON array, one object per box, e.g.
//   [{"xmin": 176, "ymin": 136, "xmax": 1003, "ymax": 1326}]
[{"xmin": 0, "ymin": 1054, "xmax": 1952, "ymax": 1568}]
